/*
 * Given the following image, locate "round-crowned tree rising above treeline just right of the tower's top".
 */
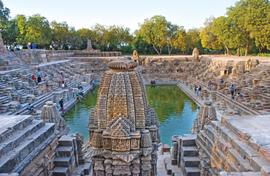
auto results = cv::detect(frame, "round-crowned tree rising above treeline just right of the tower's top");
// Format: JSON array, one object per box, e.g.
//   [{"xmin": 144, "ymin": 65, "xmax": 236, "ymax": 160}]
[{"xmin": 136, "ymin": 16, "xmax": 168, "ymax": 55}]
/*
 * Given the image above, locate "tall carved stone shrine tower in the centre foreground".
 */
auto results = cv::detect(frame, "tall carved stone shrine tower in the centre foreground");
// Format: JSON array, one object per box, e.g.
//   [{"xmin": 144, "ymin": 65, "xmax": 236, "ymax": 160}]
[{"xmin": 87, "ymin": 61, "xmax": 159, "ymax": 176}]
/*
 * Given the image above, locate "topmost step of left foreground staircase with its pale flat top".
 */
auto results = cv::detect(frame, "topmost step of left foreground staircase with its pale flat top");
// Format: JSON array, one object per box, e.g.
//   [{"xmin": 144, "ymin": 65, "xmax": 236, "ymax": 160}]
[{"xmin": 0, "ymin": 115, "xmax": 33, "ymax": 143}]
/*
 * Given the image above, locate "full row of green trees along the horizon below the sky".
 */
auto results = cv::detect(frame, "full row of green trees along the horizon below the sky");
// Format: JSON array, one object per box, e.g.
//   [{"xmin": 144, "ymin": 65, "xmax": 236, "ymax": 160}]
[{"xmin": 0, "ymin": 0, "xmax": 270, "ymax": 55}]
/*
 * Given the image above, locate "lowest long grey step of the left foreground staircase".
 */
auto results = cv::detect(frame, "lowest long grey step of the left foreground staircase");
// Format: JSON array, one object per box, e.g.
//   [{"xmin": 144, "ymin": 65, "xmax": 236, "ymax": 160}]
[{"xmin": 0, "ymin": 123, "xmax": 54, "ymax": 172}]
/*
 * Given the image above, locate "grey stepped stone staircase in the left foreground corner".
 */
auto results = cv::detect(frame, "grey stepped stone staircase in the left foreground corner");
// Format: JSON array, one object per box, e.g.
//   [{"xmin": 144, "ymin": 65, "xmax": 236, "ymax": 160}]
[{"xmin": 0, "ymin": 116, "xmax": 55, "ymax": 173}]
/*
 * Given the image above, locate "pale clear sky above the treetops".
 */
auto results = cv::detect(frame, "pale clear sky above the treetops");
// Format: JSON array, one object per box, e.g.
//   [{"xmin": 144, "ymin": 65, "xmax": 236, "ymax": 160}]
[{"xmin": 2, "ymin": 0, "xmax": 237, "ymax": 31}]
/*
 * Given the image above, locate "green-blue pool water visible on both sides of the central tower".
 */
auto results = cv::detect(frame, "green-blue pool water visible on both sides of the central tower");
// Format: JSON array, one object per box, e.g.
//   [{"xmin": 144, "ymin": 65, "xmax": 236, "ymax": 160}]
[{"xmin": 65, "ymin": 86, "xmax": 198, "ymax": 144}]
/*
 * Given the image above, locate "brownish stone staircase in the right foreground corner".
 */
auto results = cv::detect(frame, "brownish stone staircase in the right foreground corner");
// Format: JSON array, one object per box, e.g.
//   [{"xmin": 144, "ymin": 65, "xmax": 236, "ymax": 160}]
[{"xmin": 196, "ymin": 117, "xmax": 270, "ymax": 175}]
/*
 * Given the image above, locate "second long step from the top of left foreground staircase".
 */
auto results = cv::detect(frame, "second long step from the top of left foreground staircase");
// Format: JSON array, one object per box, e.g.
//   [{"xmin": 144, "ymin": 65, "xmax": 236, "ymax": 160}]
[{"xmin": 0, "ymin": 120, "xmax": 45, "ymax": 158}]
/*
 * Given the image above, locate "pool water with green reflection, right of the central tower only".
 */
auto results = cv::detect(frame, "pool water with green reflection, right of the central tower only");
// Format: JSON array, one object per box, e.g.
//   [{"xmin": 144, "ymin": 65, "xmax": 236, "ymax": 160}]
[{"xmin": 146, "ymin": 86, "xmax": 198, "ymax": 144}]
